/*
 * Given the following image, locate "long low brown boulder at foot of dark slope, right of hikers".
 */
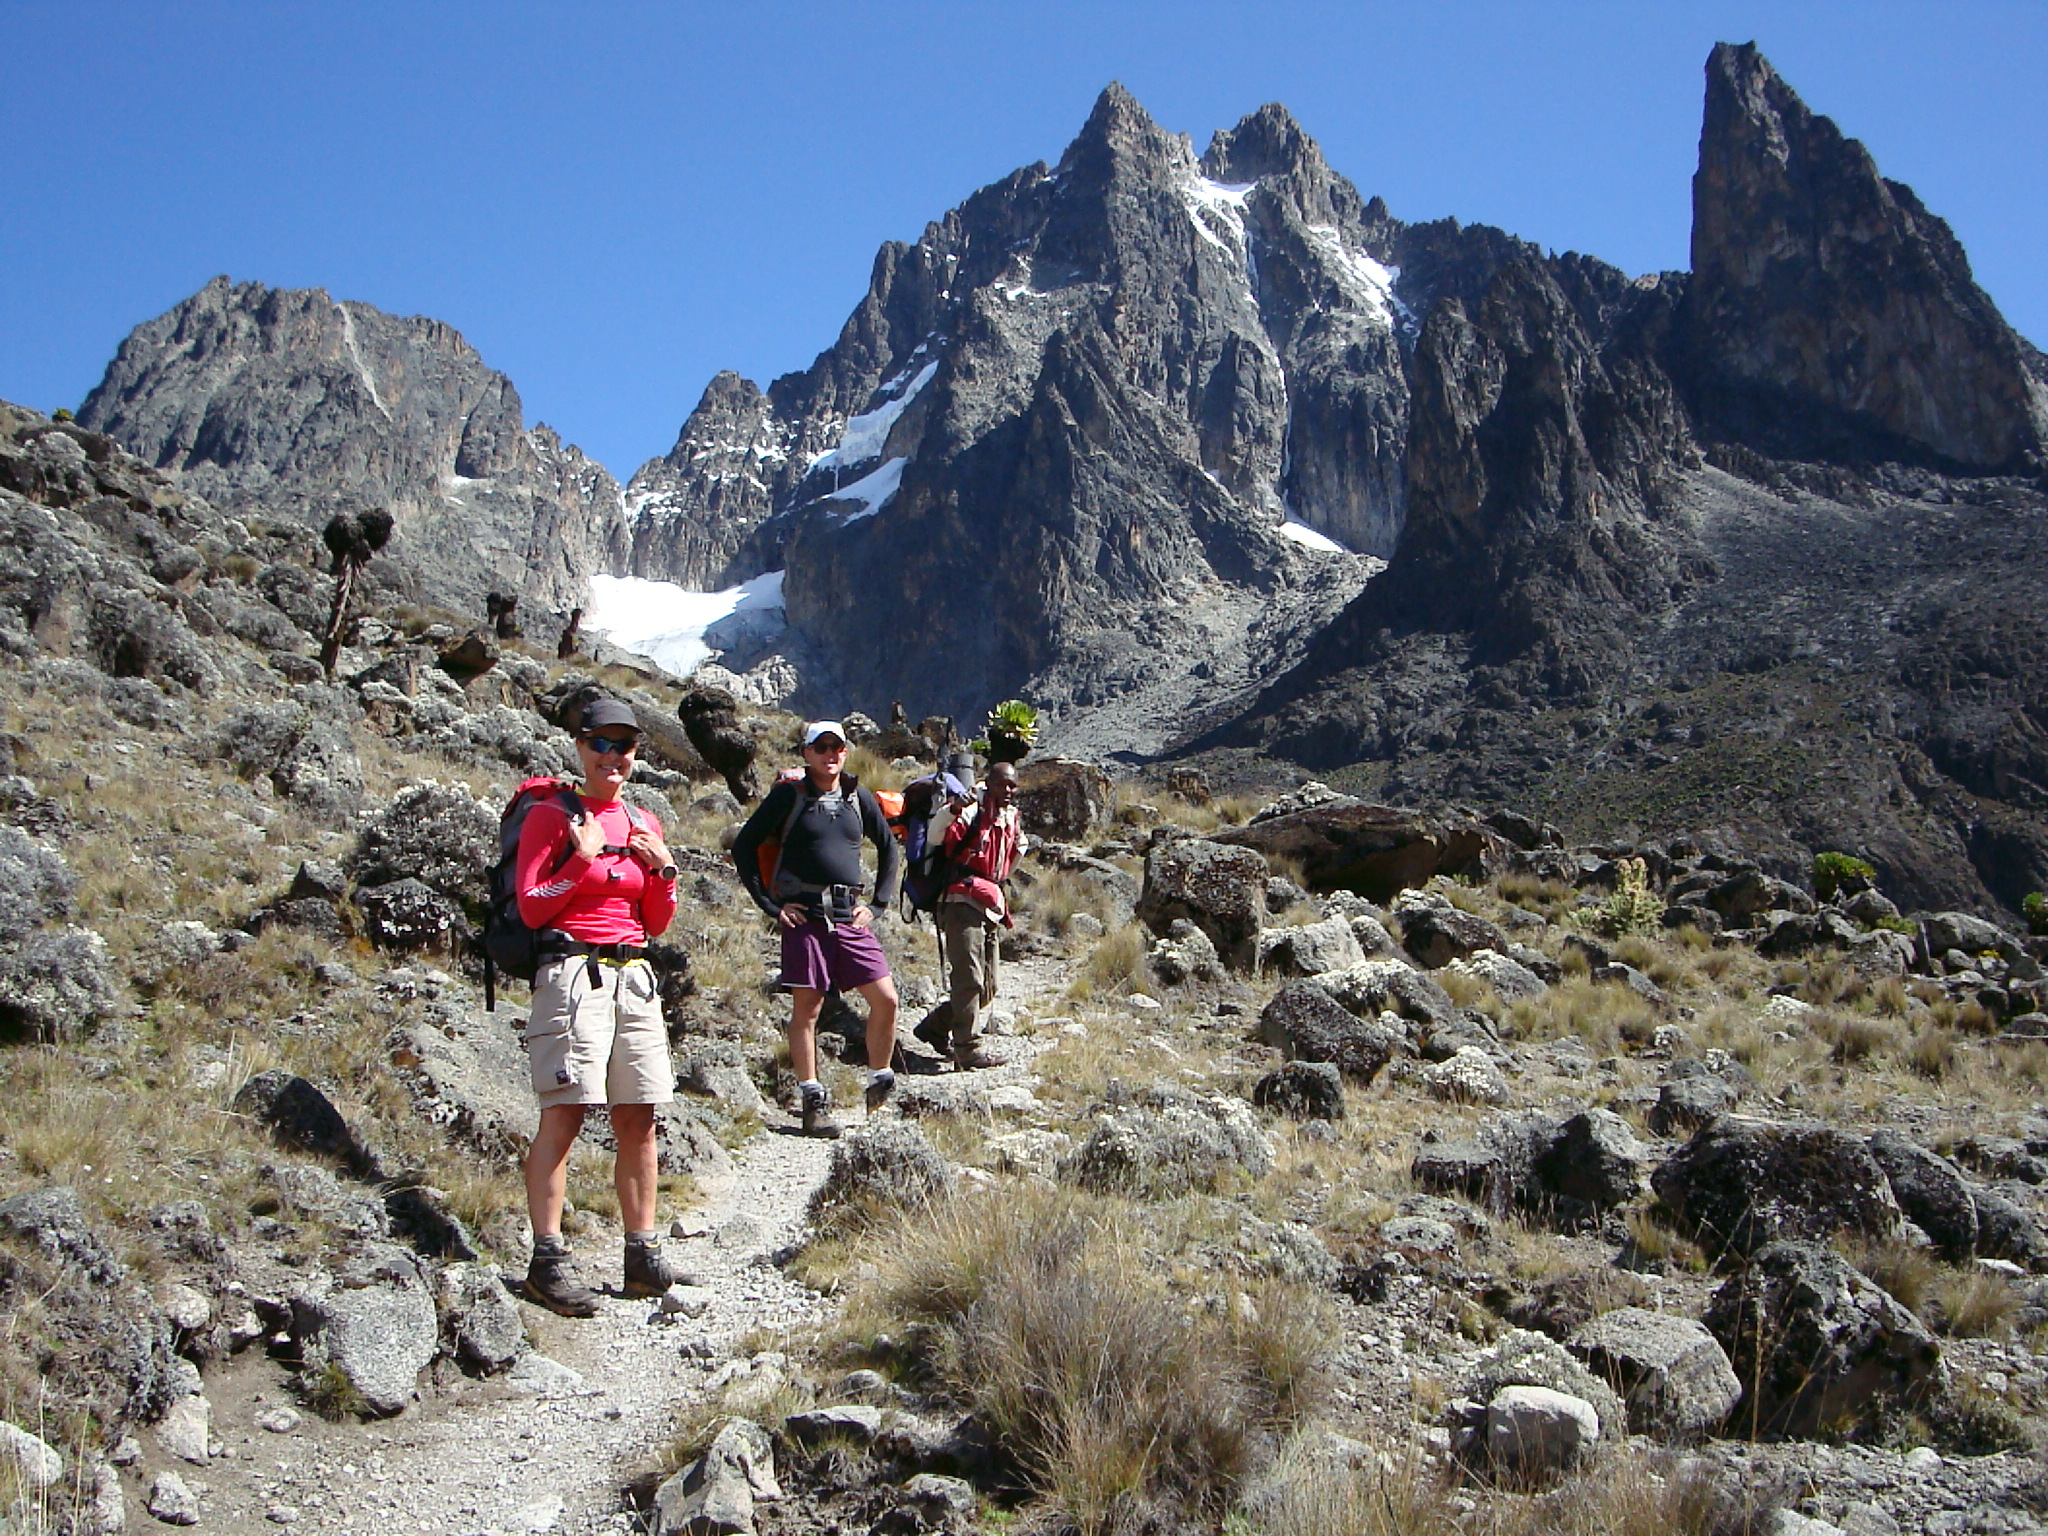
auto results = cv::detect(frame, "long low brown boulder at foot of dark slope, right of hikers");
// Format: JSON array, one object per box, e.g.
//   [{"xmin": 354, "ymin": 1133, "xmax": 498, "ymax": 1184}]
[{"xmin": 1214, "ymin": 797, "xmax": 1507, "ymax": 901}]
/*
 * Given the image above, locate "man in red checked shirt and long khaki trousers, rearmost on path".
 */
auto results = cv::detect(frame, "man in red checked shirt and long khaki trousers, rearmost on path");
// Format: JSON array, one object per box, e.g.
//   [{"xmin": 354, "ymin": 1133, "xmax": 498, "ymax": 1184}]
[{"xmin": 918, "ymin": 762, "xmax": 1024, "ymax": 1071}]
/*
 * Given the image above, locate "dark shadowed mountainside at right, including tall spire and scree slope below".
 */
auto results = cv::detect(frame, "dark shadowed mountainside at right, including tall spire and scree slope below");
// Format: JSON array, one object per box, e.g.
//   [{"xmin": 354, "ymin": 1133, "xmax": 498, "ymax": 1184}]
[{"xmin": 1202, "ymin": 45, "xmax": 2048, "ymax": 921}]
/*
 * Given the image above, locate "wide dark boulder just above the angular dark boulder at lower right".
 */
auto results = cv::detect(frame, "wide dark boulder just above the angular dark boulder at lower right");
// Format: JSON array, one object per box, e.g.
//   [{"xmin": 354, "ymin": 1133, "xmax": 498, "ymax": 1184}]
[{"xmin": 1651, "ymin": 1114, "xmax": 1898, "ymax": 1260}]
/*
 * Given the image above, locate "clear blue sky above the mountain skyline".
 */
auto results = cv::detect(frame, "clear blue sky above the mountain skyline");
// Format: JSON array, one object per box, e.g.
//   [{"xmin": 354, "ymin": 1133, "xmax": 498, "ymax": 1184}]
[{"xmin": 0, "ymin": 0, "xmax": 2048, "ymax": 479}]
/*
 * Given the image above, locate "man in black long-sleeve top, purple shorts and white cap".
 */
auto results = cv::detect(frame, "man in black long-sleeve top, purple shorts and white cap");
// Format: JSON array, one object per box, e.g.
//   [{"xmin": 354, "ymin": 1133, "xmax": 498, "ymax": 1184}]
[{"xmin": 733, "ymin": 721, "xmax": 903, "ymax": 1137}]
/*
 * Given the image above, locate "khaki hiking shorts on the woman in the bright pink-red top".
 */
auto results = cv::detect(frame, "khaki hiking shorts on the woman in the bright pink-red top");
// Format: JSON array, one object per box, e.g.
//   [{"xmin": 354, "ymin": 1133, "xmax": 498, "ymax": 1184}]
[{"xmin": 526, "ymin": 954, "xmax": 676, "ymax": 1108}]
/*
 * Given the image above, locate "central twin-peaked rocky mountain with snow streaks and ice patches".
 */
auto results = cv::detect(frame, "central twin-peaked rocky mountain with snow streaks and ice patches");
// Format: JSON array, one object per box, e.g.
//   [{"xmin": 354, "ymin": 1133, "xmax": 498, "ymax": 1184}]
[{"xmin": 629, "ymin": 86, "xmax": 1482, "ymax": 748}]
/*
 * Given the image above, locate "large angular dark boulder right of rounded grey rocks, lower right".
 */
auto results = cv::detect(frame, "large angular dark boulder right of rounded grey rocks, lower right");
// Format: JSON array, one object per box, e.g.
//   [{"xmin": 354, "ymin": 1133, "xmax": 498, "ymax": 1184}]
[{"xmin": 1704, "ymin": 1241, "xmax": 1944, "ymax": 1438}]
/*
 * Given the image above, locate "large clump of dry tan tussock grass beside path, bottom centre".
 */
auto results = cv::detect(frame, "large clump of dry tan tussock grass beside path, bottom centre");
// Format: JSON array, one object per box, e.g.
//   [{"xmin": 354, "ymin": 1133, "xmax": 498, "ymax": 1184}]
[{"xmin": 850, "ymin": 1186, "xmax": 1331, "ymax": 1532}]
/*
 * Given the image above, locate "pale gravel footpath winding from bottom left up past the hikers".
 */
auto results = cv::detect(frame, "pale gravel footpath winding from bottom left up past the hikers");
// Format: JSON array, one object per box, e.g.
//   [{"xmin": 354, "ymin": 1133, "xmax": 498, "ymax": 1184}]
[{"xmin": 174, "ymin": 961, "xmax": 1063, "ymax": 1536}]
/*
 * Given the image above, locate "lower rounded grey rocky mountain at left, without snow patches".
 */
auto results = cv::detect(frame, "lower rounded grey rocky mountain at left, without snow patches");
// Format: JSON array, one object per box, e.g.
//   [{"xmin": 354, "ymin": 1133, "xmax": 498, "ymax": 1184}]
[{"xmin": 80, "ymin": 279, "xmax": 625, "ymax": 612}]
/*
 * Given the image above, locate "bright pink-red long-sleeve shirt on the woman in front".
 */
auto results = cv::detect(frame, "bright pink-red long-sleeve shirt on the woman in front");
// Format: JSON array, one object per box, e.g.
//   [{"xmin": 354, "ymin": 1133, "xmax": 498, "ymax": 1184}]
[{"xmin": 514, "ymin": 797, "xmax": 676, "ymax": 944}]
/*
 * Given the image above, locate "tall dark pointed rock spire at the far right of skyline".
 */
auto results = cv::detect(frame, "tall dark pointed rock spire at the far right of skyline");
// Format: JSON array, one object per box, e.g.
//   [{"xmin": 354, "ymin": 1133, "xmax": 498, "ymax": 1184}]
[{"xmin": 1688, "ymin": 43, "xmax": 2048, "ymax": 469}]
